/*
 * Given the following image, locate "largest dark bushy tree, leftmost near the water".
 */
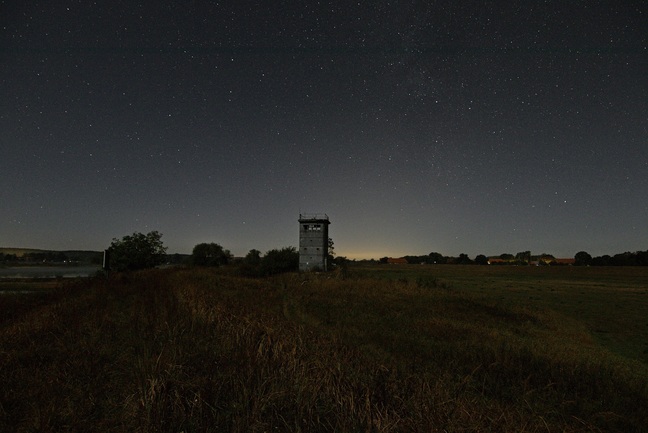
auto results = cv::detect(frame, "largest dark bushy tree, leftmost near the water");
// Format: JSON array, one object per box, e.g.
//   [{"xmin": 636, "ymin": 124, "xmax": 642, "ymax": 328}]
[{"xmin": 108, "ymin": 231, "xmax": 166, "ymax": 271}]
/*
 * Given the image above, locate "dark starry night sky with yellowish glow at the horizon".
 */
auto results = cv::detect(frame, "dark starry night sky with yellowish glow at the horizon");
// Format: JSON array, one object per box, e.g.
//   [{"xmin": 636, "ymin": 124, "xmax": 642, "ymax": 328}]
[{"xmin": 0, "ymin": 0, "xmax": 648, "ymax": 258}]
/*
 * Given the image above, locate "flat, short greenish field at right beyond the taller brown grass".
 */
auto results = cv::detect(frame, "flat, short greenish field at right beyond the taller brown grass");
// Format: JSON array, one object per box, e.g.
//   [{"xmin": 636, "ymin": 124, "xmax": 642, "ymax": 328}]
[{"xmin": 352, "ymin": 266, "xmax": 648, "ymax": 366}]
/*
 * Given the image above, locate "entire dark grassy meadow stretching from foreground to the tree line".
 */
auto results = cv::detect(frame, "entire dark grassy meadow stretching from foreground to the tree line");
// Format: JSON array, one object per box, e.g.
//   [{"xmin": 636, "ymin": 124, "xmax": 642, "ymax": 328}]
[{"xmin": 0, "ymin": 265, "xmax": 648, "ymax": 432}]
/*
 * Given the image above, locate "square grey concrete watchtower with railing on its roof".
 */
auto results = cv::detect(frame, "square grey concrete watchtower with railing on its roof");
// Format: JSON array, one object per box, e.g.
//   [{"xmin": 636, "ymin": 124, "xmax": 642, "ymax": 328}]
[{"xmin": 299, "ymin": 214, "xmax": 331, "ymax": 271}]
